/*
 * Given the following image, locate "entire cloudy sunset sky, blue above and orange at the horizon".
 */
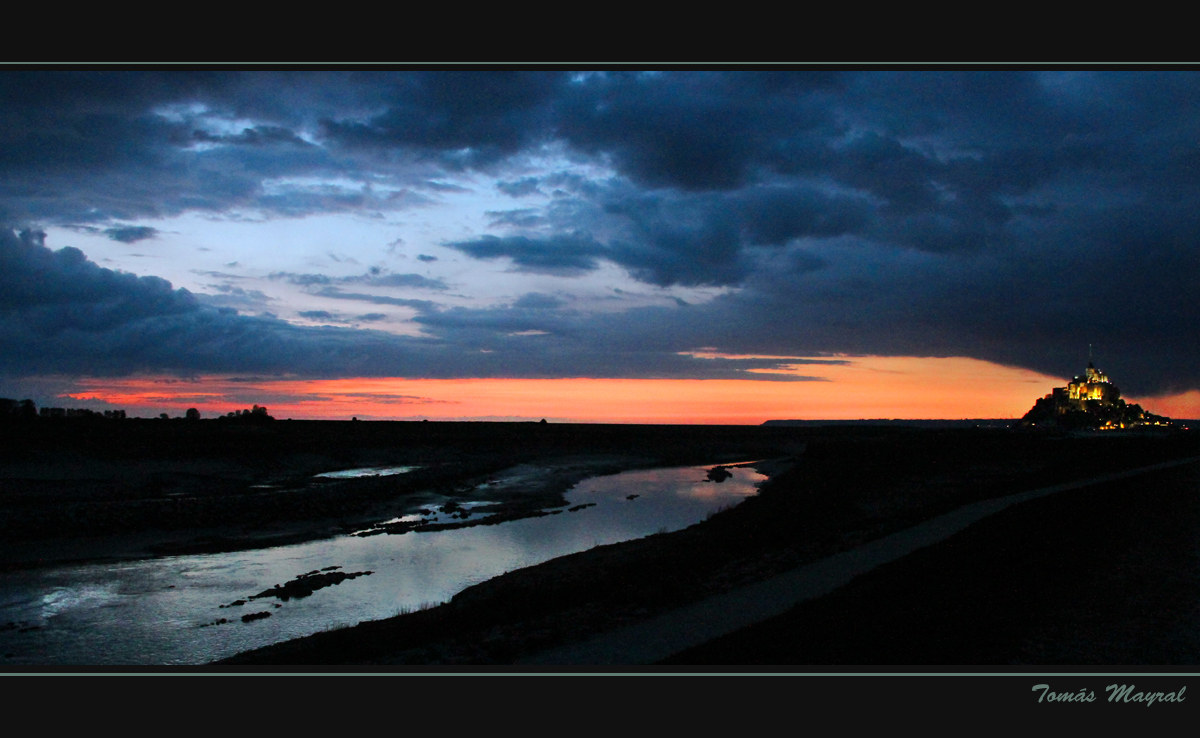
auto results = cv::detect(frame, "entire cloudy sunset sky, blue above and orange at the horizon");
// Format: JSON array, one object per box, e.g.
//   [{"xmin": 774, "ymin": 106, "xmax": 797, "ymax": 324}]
[{"xmin": 0, "ymin": 68, "xmax": 1200, "ymax": 424}]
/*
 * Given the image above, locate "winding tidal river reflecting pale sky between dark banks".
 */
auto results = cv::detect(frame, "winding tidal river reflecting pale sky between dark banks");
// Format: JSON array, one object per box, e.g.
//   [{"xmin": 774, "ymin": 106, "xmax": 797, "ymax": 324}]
[{"xmin": 0, "ymin": 467, "xmax": 766, "ymax": 666}]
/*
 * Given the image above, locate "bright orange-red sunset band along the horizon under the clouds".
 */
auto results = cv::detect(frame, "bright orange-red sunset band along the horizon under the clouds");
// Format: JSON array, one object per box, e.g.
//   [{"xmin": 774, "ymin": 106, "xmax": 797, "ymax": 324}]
[{"xmin": 54, "ymin": 356, "xmax": 1161, "ymax": 425}]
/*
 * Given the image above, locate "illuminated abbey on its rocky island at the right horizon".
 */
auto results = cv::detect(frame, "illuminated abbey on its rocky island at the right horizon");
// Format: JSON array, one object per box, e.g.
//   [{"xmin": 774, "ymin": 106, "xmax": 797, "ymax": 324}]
[{"xmin": 1016, "ymin": 361, "xmax": 1172, "ymax": 431}]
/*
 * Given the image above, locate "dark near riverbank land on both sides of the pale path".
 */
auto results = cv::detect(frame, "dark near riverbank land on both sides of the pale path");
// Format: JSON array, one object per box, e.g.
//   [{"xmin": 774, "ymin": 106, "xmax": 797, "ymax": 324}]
[{"xmin": 222, "ymin": 427, "xmax": 1200, "ymax": 666}]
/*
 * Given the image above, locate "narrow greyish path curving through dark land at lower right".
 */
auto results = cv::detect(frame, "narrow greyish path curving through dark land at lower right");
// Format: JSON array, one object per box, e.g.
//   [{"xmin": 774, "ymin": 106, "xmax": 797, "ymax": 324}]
[{"xmin": 520, "ymin": 456, "xmax": 1200, "ymax": 665}]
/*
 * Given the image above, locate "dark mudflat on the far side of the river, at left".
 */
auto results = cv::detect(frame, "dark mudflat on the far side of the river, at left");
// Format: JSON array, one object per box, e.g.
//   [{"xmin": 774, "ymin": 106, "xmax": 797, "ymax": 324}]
[{"xmin": 0, "ymin": 419, "xmax": 797, "ymax": 569}]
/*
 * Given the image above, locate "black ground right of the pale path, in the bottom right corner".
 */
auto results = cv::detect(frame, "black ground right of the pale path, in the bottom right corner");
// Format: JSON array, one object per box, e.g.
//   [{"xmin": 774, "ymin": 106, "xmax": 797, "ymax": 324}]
[{"xmin": 664, "ymin": 463, "xmax": 1200, "ymax": 666}]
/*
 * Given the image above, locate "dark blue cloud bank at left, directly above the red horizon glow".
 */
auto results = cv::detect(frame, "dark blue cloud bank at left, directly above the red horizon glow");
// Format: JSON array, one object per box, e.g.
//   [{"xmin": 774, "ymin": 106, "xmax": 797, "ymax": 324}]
[{"xmin": 0, "ymin": 229, "xmax": 806, "ymax": 378}]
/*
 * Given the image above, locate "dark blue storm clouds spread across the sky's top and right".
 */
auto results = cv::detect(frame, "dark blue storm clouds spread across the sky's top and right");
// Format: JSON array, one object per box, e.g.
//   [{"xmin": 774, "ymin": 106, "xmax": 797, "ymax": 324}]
[{"xmin": 7, "ymin": 71, "xmax": 1200, "ymax": 392}]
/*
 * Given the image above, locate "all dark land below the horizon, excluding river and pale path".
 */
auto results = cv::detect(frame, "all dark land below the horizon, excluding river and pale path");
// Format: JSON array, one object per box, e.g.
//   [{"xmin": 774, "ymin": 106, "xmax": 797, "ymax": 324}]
[{"xmin": 0, "ymin": 419, "xmax": 1200, "ymax": 667}]
